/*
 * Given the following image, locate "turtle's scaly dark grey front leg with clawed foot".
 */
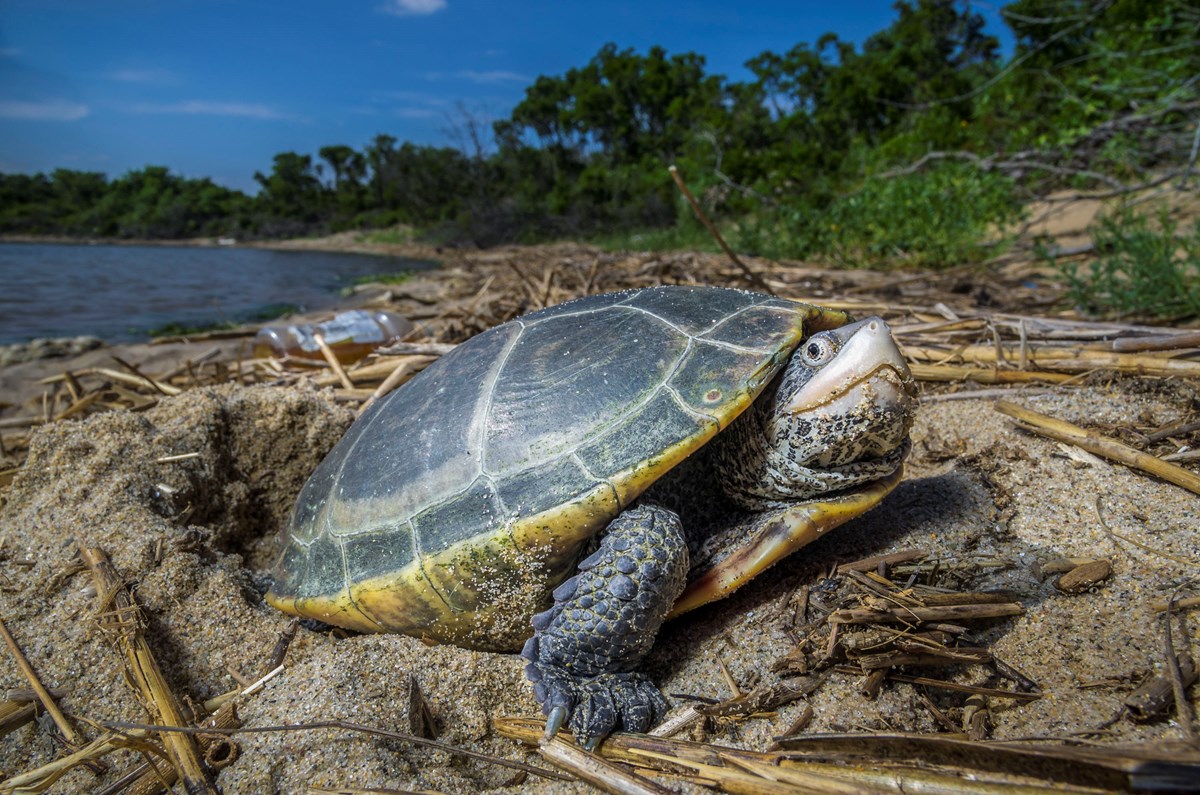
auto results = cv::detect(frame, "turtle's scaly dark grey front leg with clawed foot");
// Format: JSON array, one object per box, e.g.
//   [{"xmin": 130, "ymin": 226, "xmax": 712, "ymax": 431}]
[{"xmin": 521, "ymin": 506, "xmax": 688, "ymax": 749}]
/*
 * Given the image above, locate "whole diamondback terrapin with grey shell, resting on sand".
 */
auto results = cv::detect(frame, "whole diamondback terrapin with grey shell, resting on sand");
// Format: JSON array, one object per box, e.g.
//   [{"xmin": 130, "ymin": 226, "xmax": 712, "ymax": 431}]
[{"xmin": 266, "ymin": 287, "xmax": 916, "ymax": 745}]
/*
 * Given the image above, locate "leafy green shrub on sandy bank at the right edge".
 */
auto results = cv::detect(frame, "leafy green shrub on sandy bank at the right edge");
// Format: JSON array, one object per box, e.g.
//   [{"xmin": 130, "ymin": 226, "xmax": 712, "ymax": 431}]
[{"xmin": 1040, "ymin": 209, "xmax": 1200, "ymax": 319}]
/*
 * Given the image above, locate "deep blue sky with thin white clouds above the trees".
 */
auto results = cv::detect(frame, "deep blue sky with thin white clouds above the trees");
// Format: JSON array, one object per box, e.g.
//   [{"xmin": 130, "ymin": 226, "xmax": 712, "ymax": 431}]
[{"xmin": 0, "ymin": 0, "xmax": 1003, "ymax": 191}]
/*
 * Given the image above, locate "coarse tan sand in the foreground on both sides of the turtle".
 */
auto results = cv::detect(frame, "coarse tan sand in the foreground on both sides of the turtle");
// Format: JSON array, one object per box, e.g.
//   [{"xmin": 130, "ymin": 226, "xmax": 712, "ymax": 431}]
[{"xmin": 0, "ymin": 246, "xmax": 1200, "ymax": 793}]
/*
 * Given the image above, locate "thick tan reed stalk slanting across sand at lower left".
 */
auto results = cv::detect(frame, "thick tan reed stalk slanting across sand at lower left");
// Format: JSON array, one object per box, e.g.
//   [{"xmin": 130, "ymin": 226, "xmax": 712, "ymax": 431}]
[{"xmin": 79, "ymin": 544, "xmax": 217, "ymax": 795}]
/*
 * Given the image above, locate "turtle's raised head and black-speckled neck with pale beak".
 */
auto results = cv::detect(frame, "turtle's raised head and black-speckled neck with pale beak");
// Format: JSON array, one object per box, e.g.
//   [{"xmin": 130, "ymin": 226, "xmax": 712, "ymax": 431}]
[{"xmin": 720, "ymin": 317, "xmax": 917, "ymax": 509}]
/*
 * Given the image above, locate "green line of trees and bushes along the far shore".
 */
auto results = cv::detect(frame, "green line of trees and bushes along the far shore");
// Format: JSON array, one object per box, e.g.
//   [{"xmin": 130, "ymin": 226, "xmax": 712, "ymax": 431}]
[{"xmin": 0, "ymin": 0, "xmax": 1200, "ymax": 263}]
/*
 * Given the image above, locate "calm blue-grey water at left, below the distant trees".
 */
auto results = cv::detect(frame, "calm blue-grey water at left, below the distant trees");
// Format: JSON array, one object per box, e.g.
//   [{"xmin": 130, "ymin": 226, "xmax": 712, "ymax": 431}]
[{"xmin": 0, "ymin": 244, "xmax": 433, "ymax": 345}]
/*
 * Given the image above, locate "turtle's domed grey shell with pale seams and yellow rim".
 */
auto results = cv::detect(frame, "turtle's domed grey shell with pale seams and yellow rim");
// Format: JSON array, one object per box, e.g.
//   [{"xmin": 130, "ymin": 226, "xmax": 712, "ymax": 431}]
[{"xmin": 266, "ymin": 287, "xmax": 848, "ymax": 650}]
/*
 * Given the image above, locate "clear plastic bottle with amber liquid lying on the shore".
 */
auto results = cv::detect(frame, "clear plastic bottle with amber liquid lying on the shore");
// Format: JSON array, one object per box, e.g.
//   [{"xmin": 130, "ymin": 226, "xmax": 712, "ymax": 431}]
[{"xmin": 254, "ymin": 309, "xmax": 413, "ymax": 364}]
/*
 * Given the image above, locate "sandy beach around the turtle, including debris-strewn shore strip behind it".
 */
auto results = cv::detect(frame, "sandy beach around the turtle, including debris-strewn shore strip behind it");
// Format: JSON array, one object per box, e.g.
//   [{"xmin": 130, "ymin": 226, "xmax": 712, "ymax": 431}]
[{"xmin": 0, "ymin": 241, "xmax": 1200, "ymax": 793}]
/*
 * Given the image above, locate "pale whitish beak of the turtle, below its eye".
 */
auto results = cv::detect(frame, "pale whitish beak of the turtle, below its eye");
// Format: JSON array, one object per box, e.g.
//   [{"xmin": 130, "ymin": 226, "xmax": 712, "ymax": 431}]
[{"xmin": 787, "ymin": 317, "xmax": 917, "ymax": 414}]
